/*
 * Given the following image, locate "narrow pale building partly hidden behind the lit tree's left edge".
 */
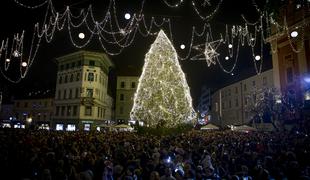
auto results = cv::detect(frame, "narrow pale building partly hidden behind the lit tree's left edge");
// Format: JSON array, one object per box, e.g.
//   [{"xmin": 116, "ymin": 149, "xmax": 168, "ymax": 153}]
[{"xmin": 115, "ymin": 76, "xmax": 139, "ymax": 122}]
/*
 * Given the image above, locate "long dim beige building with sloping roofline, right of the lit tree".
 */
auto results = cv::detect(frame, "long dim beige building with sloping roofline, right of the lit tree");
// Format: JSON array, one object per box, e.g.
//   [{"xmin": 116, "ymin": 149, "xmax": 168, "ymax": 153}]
[{"xmin": 211, "ymin": 69, "xmax": 274, "ymax": 127}]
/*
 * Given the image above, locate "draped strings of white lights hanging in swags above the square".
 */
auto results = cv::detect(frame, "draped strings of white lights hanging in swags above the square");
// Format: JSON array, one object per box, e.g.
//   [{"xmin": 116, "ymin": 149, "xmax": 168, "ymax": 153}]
[{"xmin": 0, "ymin": 0, "xmax": 310, "ymax": 83}]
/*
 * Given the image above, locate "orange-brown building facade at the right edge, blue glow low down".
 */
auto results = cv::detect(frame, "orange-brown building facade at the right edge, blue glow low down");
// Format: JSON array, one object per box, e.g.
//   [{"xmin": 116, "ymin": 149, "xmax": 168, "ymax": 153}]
[{"xmin": 267, "ymin": 0, "xmax": 310, "ymax": 100}]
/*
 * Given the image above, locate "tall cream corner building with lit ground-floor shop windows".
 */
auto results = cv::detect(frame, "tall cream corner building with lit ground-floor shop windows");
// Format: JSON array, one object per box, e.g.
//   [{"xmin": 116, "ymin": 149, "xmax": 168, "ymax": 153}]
[{"xmin": 53, "ymin": 51, "xmax": 114, "ymax": 131}]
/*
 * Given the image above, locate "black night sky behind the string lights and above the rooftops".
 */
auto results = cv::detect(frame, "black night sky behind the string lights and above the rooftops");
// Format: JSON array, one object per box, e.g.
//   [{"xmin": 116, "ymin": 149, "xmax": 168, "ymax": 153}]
[{"xmin": 0, "ymin": 0, "xmax": 272, "ymax": 104}]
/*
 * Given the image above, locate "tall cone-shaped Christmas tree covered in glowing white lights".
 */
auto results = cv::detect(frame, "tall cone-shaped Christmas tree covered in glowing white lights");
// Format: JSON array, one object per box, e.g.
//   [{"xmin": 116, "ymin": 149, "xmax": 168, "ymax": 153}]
[{"xmin": 130, "ymin": 30, "xmax": 195, "ymax": 127}]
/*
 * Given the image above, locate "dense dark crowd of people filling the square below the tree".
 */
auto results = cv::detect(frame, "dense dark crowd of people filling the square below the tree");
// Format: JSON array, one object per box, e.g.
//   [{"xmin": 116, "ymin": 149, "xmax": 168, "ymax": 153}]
[{"xmin": 0, "ymin": 129, "xmax": 310, "ymax": 180}]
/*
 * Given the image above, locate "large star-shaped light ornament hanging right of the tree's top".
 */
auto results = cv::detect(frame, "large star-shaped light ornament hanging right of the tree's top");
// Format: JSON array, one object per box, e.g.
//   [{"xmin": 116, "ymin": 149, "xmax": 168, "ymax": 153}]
[{"xmin": 191, "ymin": 39, "xmax": 223, "ymax": 67}]
